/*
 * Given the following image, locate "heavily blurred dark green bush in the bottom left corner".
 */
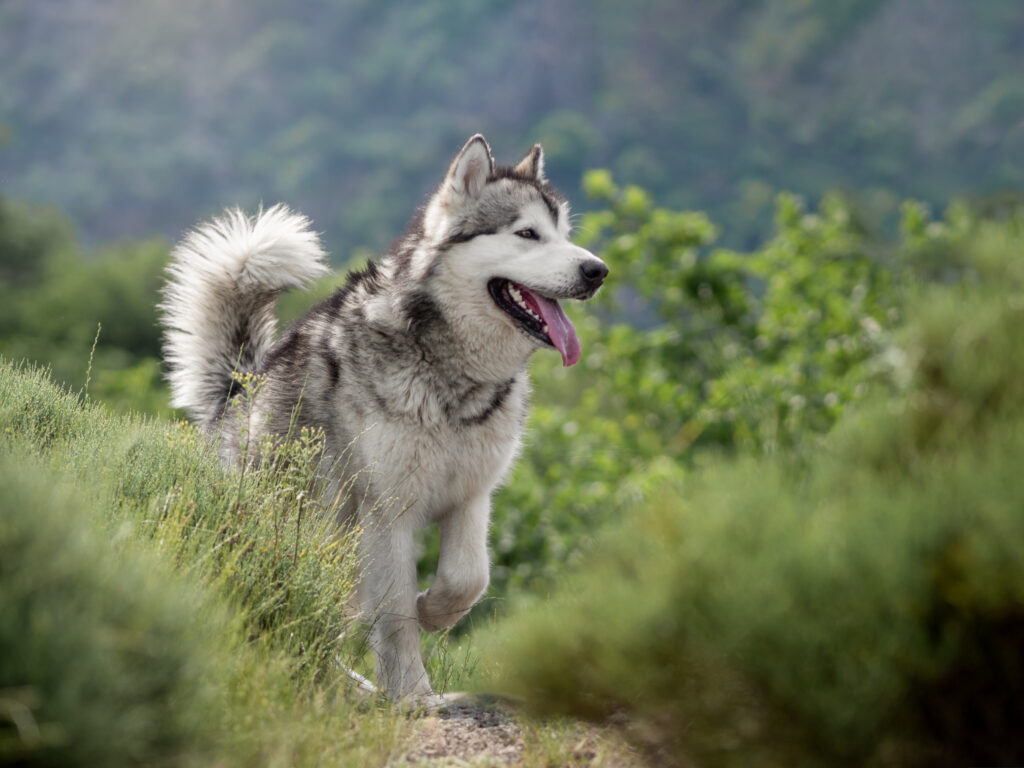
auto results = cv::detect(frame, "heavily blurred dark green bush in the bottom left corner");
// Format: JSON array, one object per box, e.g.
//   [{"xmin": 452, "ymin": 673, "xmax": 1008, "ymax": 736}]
[{"xmin": 0, "ymin": 452, "xmax": 227, "ymax": 766}]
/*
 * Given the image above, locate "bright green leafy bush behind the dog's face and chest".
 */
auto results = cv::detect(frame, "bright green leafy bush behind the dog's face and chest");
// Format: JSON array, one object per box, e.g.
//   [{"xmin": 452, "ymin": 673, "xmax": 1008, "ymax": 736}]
[{"xmin": 483, "ymin": 171, "xmax": 979, "ymax": 613}]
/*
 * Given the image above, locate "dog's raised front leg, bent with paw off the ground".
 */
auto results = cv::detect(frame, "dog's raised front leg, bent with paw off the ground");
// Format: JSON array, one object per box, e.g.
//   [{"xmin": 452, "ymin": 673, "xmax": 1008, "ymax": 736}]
[{"xmin": 416, "ymin": 495, "xmax": 490, "ymax": 632}]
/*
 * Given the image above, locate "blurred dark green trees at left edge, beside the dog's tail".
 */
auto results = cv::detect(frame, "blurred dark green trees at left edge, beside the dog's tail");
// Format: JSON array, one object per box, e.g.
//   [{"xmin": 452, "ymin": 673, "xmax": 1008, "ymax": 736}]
[{"xmin": 0, "ymin": 197, "xmax": 171, "ymax": 415}]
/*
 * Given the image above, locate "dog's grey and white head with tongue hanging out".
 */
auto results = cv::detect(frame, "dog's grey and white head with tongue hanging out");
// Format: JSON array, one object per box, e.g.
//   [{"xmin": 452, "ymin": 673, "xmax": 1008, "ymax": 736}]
[{"xmin": 423, "ymin": 134, "xmax": 608, "ymax": 366}]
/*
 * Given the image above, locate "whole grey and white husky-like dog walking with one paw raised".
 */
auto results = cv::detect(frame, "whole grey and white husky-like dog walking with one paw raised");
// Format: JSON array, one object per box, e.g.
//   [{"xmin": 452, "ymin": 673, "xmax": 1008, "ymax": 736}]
[{"xmin": 161, "ymin": 135, "xmax": 608, "ymax": 698}]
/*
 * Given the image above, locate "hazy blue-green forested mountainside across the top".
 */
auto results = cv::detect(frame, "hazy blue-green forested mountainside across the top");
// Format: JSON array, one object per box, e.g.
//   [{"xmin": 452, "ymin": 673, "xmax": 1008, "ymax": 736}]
[{"xmin": 0, "ymin": 0, "xmax": 1024, "ymax": 261}]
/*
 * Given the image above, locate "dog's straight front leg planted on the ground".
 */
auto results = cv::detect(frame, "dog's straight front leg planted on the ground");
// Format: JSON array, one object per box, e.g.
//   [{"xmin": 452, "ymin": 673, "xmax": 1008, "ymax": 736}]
[{"xmin": 358, "ymin": 517, "xmax": 431, "ymax": 698}]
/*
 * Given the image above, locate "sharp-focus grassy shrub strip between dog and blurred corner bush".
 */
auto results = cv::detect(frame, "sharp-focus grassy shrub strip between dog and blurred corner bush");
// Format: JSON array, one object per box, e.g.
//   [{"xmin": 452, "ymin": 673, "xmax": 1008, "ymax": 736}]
[{"xmin": 0, "ymin": 360, "xmax": 357, "ymax": 676}]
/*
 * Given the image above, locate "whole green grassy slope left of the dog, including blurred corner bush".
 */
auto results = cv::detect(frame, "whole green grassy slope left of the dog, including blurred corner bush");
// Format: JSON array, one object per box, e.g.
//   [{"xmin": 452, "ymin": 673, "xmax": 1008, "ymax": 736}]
[{"xmin": 0, "ymin": 361, "xmax": 404, "ymax": 766}]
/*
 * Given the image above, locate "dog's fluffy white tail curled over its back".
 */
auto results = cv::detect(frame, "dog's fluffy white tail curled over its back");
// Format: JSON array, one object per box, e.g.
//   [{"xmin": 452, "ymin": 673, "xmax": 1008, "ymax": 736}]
[{"xmin": 160, "ymin": 205, "xmax": 328, "ymax": 424}]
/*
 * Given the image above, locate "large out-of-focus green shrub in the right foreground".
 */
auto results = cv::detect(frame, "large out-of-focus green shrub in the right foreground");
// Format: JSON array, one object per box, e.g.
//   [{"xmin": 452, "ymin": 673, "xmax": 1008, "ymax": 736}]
[{"xmin": 481, "ymin": 225, "xmax": 1024, "ymax": 766}]
